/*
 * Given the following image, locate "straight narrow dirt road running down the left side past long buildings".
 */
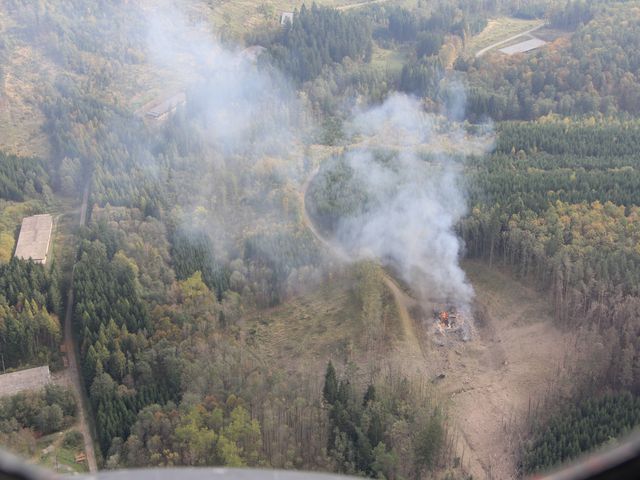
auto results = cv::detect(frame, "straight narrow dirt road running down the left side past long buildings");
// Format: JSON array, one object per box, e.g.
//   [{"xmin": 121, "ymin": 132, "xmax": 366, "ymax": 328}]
[{"xmin": 64, "ymin": 185, "xmax": 98, "ymax": 473}]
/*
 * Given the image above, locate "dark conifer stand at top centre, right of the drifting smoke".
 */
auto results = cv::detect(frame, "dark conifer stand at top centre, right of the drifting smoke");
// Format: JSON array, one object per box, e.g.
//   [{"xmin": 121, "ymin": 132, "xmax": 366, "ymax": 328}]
[{"xmin": 263, "ymin": 3, "xmax": 372, "ymax": 83}]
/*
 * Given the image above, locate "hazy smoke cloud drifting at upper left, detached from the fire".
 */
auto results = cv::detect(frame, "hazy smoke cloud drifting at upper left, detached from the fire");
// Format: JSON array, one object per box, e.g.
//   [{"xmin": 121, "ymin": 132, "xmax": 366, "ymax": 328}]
[{"xmin": 147, "ymin": 2, "xmax": 303, "ymax": 155}]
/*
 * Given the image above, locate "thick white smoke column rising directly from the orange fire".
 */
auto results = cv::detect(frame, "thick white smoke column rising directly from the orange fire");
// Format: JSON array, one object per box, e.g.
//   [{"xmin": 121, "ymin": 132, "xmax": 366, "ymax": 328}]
[{"xmin": 338, "ymin": 94, "xmax": 490, "ymax": 306}]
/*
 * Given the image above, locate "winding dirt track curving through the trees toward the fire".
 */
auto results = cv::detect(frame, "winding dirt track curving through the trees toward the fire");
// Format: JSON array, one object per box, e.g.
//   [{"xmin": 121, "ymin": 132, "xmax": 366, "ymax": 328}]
[{"xmin": 300, "ymin": 167, "xmax": 426, "ymax": 358}]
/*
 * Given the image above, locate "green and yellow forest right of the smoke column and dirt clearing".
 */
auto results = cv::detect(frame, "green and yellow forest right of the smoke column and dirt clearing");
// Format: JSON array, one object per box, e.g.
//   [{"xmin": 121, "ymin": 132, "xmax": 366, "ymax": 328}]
[{"xmin": 460, "ymin": 119, "xmax": 640, "ymax": 473}]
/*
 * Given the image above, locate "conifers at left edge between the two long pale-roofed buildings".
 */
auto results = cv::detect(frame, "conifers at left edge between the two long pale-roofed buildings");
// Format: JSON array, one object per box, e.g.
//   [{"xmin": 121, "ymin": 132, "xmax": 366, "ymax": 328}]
[{"xmin": 0, "ymin": 257, "xmax": 61, "ymax": 368}]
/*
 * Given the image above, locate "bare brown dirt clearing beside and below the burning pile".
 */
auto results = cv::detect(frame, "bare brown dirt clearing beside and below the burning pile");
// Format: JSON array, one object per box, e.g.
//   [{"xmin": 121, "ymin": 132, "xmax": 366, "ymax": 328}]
[{"xmin": 439, "ymin": 260, "xmax": 574, "ymax": 479}]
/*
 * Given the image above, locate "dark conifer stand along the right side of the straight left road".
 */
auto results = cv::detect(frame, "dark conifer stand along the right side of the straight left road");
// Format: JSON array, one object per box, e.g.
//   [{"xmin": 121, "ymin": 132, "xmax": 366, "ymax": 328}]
[{"xmin": 73, "ymin": 234, "xmax": 155, "ymax": 452}]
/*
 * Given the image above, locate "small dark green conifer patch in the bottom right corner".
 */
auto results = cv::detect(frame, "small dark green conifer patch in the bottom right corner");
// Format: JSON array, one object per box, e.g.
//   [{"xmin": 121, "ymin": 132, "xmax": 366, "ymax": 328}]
[{"xmin": 520, "ymin": 392, "xmax": 640, "ymax": 475}]
